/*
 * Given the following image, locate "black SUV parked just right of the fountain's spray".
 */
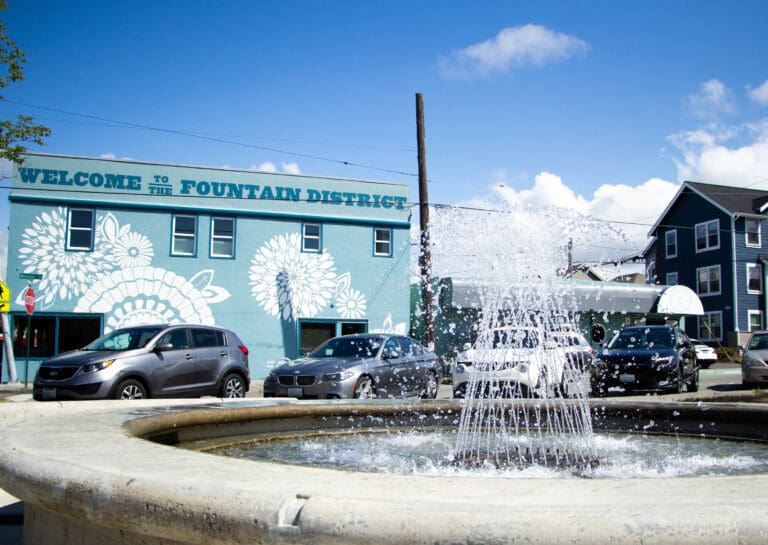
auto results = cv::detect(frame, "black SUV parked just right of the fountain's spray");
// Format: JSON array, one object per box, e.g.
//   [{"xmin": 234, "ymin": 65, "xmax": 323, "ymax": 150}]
[{"xmin": 591, "ymin": 325, "xmax": 699, "ymax": 396}]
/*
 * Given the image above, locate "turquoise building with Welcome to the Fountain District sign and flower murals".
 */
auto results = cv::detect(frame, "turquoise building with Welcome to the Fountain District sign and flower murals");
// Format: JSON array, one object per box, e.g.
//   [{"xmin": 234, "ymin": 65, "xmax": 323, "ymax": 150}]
[{"xmin": 4, "ymin": 154, "xmax": 411, "ymax": 380}]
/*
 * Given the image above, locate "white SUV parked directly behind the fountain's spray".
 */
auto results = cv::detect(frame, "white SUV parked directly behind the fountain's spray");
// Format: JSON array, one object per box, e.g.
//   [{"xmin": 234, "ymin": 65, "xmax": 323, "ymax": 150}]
[{"xmin": 452, "ymin": 326, "xmax": 592, "ymax": 398}]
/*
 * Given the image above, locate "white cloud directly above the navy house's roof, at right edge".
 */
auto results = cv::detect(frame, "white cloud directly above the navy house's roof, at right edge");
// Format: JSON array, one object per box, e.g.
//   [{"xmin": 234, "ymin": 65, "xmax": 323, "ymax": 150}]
[{"xmin": 668, "ymin": 119, "xmax": 768, "ymax": 188}]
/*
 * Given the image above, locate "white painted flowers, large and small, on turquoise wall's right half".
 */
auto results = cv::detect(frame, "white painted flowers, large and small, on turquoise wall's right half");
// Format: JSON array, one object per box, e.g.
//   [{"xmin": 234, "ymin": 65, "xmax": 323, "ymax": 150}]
[{"xmin": 248, "ymin": 233, "xmax": 367, "ymax": 321}]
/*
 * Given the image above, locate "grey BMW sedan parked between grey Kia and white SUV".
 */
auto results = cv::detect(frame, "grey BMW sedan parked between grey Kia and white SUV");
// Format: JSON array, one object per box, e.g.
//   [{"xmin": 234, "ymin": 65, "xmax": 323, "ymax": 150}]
[{"xmin": 264, "ymin": 333, "xmax": 442, "ymax": 399}]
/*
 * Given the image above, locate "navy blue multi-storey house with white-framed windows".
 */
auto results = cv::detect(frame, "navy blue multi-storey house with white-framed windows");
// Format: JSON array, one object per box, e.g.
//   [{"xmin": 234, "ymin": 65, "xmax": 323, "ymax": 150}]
[{"xmin": 645, "ymin": 182, "xmax": 768, "ymax": 346}]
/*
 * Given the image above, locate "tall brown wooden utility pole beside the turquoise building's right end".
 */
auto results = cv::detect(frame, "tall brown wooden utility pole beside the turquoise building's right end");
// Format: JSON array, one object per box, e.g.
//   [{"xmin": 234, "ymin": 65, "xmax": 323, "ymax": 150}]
[{"xmin": 416, "ymin": 93, "xmax": 435, "ymax": 350}]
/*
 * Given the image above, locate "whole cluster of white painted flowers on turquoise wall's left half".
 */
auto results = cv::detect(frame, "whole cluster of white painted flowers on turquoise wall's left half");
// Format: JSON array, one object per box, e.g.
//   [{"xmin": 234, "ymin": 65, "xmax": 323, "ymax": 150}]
[{"xmin": 16, "ymin": 208, "xmax": 230, "ymax": 331}]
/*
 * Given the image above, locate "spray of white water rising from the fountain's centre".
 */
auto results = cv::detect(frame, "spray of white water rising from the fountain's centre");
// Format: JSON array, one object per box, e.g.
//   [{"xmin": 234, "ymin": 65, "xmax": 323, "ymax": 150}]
[{"xmin": 430, "ymin": 202, "xmax": 616, "ymax": 467}]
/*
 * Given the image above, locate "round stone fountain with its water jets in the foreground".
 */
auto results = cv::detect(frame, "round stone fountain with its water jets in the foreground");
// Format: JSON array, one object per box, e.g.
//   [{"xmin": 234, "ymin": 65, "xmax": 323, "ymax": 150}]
[{"xmin": 0, "ymin": 202, "xmax": 768, "ymax": 545}]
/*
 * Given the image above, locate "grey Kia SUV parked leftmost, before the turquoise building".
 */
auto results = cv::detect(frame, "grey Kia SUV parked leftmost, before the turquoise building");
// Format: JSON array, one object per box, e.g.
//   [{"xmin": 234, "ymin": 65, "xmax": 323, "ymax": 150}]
[{"xmin": 33, "ymin": 324, "xmax": 250, "ymax": 401}]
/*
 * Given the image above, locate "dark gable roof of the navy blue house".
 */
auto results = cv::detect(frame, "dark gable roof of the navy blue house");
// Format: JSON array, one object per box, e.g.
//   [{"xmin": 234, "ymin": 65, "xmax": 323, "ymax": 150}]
[{"xmin": 646, "ymin": 182, "xmax": 768, "ymax": 236}]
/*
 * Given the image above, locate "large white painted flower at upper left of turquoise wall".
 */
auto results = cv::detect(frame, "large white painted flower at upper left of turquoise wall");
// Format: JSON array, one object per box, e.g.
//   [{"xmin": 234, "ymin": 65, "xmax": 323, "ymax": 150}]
[{"xmin": 17, "ymin": 208, "xmax": 115, "ymax": 310}]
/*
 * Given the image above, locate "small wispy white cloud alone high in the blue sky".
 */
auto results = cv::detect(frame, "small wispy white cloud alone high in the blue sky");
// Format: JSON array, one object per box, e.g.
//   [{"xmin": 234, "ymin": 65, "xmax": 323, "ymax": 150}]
[{"xmin": 438, "ymin": 24, "xmax": 589, "ymax": 78}]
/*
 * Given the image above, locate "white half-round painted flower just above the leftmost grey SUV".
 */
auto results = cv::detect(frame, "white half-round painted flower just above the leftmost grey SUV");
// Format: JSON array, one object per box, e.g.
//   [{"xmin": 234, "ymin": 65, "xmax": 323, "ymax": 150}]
[{"xmin": 75, "ymin": 267, "xmax": 219, "ymax": 332}]
